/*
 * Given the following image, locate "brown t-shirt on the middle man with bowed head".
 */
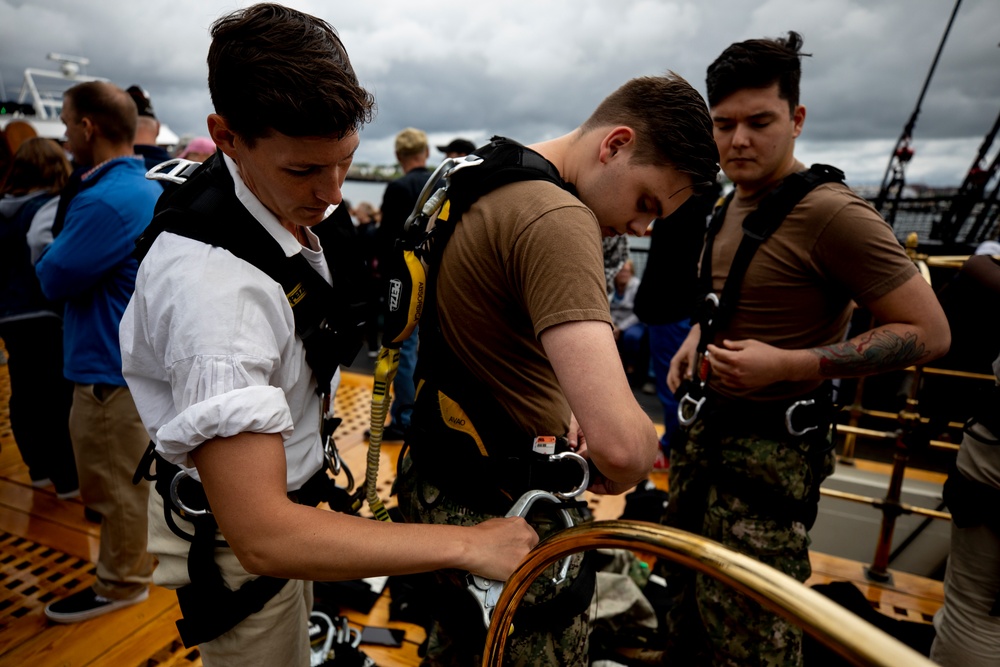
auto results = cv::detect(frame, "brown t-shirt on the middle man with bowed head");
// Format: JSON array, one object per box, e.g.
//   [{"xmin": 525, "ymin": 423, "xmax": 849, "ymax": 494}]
[{"xmin": 437, "ymin": 181, "xmax": 611, "ymax": 435}]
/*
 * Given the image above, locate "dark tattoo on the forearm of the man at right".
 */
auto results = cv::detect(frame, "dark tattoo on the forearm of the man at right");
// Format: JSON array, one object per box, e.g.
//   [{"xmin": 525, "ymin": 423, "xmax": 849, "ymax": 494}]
[{"xmin": 812, "ymin": 329, "xmax": 924, "ymax": 377}]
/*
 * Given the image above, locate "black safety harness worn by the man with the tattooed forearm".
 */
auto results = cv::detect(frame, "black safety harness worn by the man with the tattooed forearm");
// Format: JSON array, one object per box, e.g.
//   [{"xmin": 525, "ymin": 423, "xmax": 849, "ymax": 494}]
[{"xmin": 677, "ymin": 164, "xmax": 844, "ymax": 527}]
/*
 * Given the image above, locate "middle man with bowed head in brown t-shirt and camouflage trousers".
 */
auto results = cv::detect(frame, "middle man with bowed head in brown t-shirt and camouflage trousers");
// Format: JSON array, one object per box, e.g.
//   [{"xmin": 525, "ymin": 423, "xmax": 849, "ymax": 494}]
[{"xmin": 397, "ymin": 74, "xmax": 718, "ymax": 665}]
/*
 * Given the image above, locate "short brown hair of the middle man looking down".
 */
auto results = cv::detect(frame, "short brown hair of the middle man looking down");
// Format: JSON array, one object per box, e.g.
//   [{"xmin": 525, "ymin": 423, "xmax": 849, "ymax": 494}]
[{"xmin": 582, "ymin": 72, "xmax": 719, "ymax": 191}]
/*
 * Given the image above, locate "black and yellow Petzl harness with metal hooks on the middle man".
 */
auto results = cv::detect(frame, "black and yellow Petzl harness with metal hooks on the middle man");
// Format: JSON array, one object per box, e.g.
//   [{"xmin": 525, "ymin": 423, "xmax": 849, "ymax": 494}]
[{"xmin": 366, "ymin": 137, "xmax": 595, "ymax": 627}]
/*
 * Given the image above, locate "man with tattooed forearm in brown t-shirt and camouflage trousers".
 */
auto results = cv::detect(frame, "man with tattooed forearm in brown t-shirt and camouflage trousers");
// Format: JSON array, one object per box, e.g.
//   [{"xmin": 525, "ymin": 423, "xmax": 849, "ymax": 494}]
[{"xmin": 666, "ymin": 32, "xmax": 950, "ymax": 665}]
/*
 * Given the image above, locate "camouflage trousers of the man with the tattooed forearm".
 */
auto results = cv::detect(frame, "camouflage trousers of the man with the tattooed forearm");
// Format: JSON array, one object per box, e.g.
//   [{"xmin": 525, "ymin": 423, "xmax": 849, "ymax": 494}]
[{"xmin": 665, "ymin": 421, "xmax": 834, "ymax": 667}]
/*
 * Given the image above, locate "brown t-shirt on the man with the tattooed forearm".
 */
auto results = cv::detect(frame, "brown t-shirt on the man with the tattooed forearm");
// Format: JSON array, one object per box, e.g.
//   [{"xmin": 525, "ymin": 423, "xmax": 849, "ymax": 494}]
[{"xmin": 709, "ymin": 172, "xmax": 917, "ymax": 399}]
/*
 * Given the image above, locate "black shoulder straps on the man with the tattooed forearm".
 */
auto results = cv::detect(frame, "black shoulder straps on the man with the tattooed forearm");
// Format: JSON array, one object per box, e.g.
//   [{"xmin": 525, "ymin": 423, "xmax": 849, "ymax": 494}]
[{"xmin": 699, "ymin": 164, "xmax": 844, "ymax": 352}]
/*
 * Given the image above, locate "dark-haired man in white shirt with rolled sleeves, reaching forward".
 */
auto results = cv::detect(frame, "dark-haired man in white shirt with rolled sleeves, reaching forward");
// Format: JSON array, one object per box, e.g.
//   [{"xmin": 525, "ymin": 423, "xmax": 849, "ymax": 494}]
[{"xmin": 121, "ymin": 4, "xmax": 537, "ymax": 667}]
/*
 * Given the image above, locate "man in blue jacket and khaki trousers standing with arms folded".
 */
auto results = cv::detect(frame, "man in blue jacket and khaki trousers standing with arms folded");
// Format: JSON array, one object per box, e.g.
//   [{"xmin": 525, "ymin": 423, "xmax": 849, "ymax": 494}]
[{"xmin": 35, "ymin": 81, "xmax": 163, "ymax": 623}]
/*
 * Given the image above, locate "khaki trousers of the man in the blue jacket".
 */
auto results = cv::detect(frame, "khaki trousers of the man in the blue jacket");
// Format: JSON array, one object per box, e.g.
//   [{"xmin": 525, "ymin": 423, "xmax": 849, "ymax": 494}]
[{"xmin": 69, "ymin": 384, "xmax": 154, "ymax": 600}]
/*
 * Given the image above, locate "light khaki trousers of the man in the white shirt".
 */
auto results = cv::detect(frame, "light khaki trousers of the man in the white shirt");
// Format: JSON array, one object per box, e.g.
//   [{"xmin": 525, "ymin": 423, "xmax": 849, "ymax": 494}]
[{"xmin": 149, "ymin": 491, "xmax": 313, "ymax": 667}]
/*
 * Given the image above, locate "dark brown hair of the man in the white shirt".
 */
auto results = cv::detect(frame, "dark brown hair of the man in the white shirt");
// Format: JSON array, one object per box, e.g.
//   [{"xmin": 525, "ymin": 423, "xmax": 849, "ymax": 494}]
[{"xmin": 208, "ymin": 3, "xmax": 375, "ymax": 145}]
